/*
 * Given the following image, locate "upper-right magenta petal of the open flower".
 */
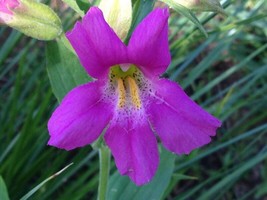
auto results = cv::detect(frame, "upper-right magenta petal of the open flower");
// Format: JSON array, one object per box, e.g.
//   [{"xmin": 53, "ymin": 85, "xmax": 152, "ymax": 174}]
[{"xmin": 128, "ymin": 9, "xmax": 171, "ymax": 76}]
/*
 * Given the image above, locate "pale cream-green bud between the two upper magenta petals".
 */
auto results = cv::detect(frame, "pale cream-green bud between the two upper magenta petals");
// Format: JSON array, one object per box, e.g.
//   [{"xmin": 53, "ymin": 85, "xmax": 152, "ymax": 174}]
[{"xmin": 99, "ymin": 0, "xmax": 132, "ymax": 40}]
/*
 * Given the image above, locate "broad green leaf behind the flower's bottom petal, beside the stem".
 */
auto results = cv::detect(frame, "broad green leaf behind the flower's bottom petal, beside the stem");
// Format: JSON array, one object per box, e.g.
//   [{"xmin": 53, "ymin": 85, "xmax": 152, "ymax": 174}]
[{"xmin": 107, "ymin": 145, "xmax": 175, "ymax": 200}]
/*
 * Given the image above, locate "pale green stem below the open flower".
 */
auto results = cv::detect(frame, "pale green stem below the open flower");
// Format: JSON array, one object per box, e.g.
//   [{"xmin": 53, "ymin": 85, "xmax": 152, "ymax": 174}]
[{"xmin": 97, "ymin": 145, "xmax": 110, "ymax": 200}]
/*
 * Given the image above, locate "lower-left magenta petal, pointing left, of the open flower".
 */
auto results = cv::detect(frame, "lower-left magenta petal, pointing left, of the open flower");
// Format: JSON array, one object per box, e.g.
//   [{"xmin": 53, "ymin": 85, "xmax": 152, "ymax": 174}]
[{"xmin": 48, "ymin": 81, "xmax": 112, "ymax": 150}]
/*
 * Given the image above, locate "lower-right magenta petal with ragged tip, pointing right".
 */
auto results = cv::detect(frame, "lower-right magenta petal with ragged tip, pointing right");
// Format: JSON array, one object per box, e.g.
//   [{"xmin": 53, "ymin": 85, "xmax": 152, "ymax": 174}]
[{"xmin": 147, "ymin": 79, "xmax": 221, "ymax": 154}]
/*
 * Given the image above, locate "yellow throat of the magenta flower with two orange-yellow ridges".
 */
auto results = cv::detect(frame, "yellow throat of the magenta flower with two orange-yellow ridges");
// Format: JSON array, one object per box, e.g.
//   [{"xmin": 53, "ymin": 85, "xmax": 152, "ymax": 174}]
[{"xmin": 109, "ymin": 65, "xmax": 142, "ymax": 109}]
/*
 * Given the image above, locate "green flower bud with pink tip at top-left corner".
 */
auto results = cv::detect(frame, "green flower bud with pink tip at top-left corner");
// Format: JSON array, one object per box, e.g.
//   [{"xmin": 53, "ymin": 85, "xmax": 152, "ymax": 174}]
[{"xmin": 0, "ymin": 0, "xmax": 62, "ymax": 40}]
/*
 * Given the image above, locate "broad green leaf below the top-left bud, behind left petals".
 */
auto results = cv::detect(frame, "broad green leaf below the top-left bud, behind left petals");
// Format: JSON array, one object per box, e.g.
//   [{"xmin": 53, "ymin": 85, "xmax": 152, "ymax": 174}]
[{"xmin": 46, "ymin": 38, "xmax": 91, "ymax": 101}]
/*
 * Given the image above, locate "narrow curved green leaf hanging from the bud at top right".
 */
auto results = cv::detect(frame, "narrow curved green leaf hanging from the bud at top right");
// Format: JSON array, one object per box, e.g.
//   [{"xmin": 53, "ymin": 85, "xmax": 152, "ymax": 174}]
[{"xmin": 161, "ymin": 0, "xmax": 208, "ymax": 37}]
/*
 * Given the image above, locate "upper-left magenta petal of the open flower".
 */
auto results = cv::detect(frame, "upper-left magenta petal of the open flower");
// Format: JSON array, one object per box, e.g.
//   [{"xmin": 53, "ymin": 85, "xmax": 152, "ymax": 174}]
[{"xmin": 67, "ymin": 7, "xmax": 128, "ymax": 78}]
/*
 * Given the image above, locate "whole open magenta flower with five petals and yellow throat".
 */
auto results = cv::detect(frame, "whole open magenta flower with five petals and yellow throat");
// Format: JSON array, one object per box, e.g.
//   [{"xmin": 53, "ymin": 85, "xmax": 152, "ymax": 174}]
[{"xmin": 48, "ymin": 7, "xmax": 221, "ymax": 185}]
